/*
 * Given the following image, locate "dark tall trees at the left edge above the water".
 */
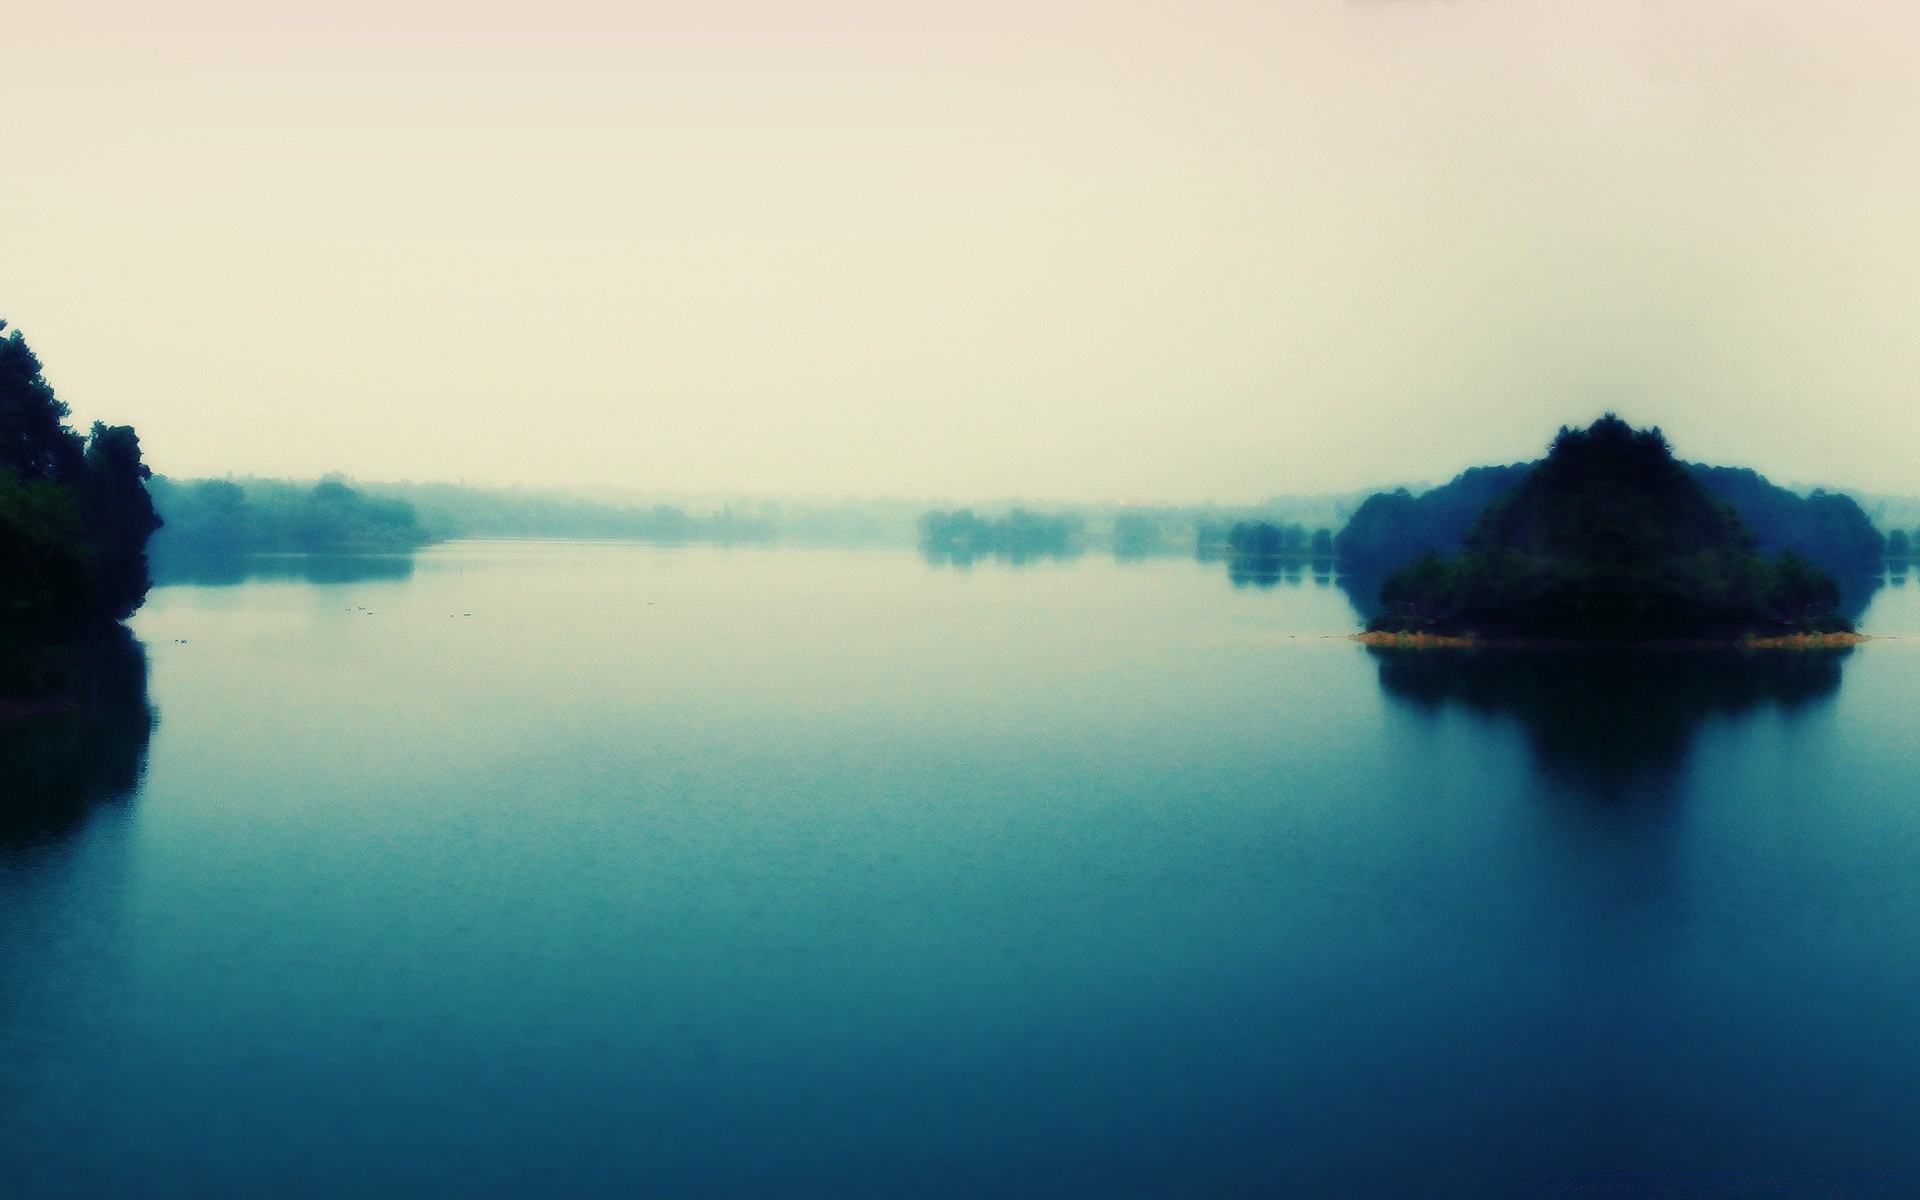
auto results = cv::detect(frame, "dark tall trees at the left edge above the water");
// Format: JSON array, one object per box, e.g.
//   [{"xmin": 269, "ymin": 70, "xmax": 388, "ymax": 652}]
[{"xmin": 0, "ymin": 323, "xmax": 159, "ymax": 645}]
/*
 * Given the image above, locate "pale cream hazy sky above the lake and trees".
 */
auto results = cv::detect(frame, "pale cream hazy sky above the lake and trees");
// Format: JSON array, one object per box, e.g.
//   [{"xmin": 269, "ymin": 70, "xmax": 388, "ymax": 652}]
[{"xmin": 0, "ymin": 0, "xmax": 1920, "ymax": 501}]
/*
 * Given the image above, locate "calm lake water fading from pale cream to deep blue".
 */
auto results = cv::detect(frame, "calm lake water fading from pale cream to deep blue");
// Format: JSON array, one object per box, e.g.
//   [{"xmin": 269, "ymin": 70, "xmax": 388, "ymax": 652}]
[{"xmin": 0, "ymin": 543, "xmax": 1920, "ymax": 1196}]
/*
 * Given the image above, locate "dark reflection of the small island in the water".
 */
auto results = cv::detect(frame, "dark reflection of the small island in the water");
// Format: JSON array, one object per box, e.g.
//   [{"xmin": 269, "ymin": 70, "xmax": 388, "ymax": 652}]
[{"xmin": 1369, "ymin": 647, "xmax": 1853, "ymax": 799}]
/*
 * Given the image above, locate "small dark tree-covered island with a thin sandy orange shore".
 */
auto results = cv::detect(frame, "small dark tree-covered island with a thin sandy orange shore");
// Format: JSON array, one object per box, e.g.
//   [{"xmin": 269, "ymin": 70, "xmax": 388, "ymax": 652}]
[{"xmin": 1361, "ymin": 415, "xmax": 1860, "ymax": 647}]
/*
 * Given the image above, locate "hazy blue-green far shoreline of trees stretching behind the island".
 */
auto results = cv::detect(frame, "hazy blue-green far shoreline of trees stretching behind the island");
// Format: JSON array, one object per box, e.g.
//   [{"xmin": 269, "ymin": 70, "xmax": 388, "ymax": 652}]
[{"xmin": 152, "ymin": 463, "xmax": 1920, "ymax": 583}]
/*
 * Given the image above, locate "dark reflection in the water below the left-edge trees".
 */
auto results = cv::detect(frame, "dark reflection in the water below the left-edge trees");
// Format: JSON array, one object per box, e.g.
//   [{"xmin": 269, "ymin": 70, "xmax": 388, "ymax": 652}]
[{"xmin": 0, "ymin": 630, "xmax": 156, "ymax": 852}]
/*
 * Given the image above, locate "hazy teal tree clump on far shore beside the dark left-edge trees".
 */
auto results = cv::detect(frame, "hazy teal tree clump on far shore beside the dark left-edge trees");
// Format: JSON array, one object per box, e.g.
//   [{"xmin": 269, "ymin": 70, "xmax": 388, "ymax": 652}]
[{"xmin": 154, "ymin": 478, "xmax": 430, "ymax": 555}]
